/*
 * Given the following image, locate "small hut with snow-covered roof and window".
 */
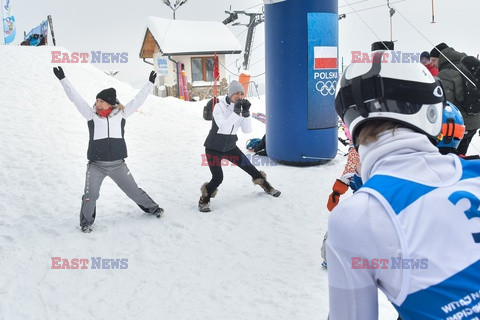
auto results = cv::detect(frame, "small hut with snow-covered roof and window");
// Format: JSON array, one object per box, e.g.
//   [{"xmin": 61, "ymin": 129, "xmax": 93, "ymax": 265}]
[{"xmin": 140, "ymin": 17, "xmax": 242, "ymax": 99}]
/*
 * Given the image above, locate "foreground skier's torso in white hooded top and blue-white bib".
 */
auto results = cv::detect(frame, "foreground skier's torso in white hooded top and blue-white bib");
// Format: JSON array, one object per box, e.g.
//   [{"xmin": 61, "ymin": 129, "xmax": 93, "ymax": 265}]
[{"xmin": 327, "ymin": 129, "xmax": 480, "ymax": 320}]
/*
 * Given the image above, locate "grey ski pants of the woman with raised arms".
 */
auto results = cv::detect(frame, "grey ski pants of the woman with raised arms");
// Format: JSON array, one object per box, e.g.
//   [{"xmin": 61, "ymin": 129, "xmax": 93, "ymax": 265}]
[{"xmin": 80, "ymin": 160, "xmax": 158, "ymax": 226}]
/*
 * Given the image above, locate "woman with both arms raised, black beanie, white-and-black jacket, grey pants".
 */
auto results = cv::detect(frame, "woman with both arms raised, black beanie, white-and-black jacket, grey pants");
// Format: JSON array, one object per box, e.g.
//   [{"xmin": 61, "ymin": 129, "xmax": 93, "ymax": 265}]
[{"xmin": 53, "ymin": 67, "xmax": 163, "ymax": 233}]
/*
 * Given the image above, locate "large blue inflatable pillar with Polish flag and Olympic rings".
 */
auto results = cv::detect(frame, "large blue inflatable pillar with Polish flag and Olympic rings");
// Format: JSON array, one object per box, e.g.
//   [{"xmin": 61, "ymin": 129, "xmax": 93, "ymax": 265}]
[{"xmin": 265, "ymin": 0, "xmax": 338, "ymax": 165}]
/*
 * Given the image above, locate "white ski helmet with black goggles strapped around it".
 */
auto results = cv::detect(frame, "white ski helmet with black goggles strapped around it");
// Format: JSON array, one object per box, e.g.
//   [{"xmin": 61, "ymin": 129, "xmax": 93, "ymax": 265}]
[{"xmin": 335, "ymin": 51, "xmax": 446, "ymax": 145}]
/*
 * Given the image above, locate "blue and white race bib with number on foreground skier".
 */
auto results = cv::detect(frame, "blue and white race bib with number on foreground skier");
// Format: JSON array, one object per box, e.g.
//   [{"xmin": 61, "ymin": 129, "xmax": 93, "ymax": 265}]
[{"xmin": 358, "ymin": 160, "xmax": 480, "ymax": 320}]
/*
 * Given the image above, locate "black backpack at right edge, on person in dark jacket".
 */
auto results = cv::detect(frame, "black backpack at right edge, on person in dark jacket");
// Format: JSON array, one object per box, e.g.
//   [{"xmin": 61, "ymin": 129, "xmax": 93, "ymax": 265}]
[{"xmin": 460, "ymin": 56, "xmax": 480, "ymax": 115}]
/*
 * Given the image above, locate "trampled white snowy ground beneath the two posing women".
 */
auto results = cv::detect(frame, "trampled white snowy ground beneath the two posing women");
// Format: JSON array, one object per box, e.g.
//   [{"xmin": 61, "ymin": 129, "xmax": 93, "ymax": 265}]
[{"xmin": 0, "ymin": 46, "xmax": 479, "ymax": 320}]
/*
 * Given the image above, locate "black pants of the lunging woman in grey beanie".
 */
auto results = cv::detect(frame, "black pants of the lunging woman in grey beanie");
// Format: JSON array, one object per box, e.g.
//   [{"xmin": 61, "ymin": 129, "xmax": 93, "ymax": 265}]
[{"xmin": 205, "ymin": 147, "xmax": 262, "ymax": 195}]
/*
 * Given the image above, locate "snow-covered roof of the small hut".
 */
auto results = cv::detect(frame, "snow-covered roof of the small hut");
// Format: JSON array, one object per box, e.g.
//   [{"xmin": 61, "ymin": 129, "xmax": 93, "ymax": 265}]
[{"xmin": 140, "ymin": 17, "xmax": 242, "ymax": 56}]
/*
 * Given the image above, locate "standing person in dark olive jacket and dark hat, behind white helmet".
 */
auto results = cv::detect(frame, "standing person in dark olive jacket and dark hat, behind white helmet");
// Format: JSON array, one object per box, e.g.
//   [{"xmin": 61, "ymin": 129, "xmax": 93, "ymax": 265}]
[{"xmin": 430, "ymin": 43, "xmax": 480, "ymax": 155}]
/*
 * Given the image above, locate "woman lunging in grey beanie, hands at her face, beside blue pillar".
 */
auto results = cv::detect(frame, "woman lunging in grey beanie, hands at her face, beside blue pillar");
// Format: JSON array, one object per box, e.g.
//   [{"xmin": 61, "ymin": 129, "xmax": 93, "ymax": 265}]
[{"xmin": 198, "ymin": 80, "xmax": 280, "ymax": 212}]
